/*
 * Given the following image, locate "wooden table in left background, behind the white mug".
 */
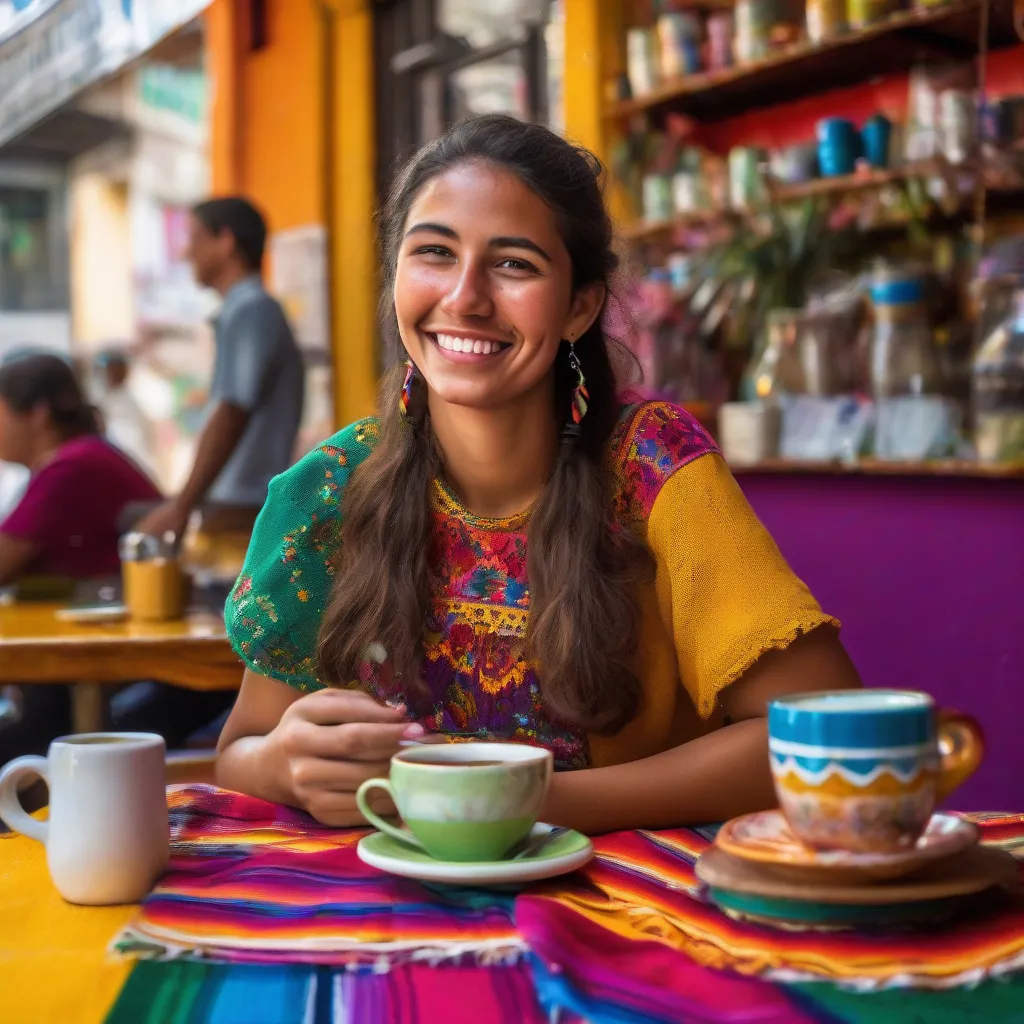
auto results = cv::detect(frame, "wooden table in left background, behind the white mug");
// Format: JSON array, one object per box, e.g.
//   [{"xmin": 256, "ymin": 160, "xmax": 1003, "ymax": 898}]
[{"xmin": 0, "ymin": 601, "xmax": 243, "ymax": 732}]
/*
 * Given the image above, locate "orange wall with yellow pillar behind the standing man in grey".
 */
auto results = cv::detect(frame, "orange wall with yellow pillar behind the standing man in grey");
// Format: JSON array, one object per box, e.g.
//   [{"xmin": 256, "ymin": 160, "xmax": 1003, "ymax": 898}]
[{"xmin": 206, "ymin": 0, "xmax": 377, "ymax": 426}]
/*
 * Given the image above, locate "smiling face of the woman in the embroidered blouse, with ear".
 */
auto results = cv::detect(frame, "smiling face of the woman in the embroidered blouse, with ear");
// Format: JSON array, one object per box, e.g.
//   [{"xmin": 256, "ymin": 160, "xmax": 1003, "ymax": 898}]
[{"xmin": 394, "ymin": 161, "xmax": 604, "ymax": 409}]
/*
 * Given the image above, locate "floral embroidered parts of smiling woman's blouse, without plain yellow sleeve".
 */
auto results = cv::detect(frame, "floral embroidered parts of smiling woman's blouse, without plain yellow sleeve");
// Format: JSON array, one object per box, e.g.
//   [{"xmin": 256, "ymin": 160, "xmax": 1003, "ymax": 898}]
[{"xmin": 227, "ymin": 402, "xmax": 717, "ymax": 769}]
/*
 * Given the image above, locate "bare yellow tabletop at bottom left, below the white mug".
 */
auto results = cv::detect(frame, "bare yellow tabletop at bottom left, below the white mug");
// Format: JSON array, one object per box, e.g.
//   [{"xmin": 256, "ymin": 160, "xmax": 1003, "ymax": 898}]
[{"xmin": 0, "ymin": 835, "xmax": 135, "ymax": 1024}]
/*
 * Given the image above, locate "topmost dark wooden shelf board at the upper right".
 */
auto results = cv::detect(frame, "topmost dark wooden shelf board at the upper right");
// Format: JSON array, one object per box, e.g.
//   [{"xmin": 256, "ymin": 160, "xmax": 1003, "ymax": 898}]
[{"xmin": 605, "ymin": 0, "xmax": 1018, "ymax": 120}]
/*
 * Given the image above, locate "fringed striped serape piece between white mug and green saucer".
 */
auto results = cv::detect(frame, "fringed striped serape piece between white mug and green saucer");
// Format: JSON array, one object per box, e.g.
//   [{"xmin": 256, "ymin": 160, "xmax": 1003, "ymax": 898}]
[{"xmin": 120, "ymin": 785, "xmax": 525, "ymax": 964}]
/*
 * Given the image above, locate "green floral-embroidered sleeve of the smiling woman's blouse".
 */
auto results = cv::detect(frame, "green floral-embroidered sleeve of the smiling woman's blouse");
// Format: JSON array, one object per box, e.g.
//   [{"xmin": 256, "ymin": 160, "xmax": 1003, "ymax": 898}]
[{"xmin": 224, "ymin": 420, "xmax": 377, "ymax": 690}]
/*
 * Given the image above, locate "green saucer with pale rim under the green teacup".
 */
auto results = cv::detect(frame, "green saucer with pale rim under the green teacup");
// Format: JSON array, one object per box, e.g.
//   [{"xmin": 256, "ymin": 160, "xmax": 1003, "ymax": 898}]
[{"xmin": 356, "ymin": 822, "xmax": 594, "ymax": 886}]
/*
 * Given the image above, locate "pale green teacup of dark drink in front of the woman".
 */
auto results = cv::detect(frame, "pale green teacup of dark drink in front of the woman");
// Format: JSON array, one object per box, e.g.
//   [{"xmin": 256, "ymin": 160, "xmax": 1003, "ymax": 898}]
[{"xmin": 355, "ymin": 743, "xmax": 552, "ymax": 861}]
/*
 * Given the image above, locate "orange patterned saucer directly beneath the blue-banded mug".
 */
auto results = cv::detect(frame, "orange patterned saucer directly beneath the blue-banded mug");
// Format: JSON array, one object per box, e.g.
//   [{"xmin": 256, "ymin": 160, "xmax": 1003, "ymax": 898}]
[{"xmin": 715, "ymin": 810, "xmax": 980, "ymax": 885}]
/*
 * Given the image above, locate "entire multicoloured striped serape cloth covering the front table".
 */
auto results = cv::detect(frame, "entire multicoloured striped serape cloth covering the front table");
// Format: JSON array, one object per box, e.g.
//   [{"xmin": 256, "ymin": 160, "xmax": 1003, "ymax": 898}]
[{"xmin": 111, "ymin": 786, "xmax": 1024, "ymax": 1024}]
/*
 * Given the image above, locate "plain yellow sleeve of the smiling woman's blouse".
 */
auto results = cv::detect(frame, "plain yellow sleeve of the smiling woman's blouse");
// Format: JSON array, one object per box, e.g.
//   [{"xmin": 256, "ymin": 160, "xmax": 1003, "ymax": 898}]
[{"xmin": 647, "ymin": 455, "xmax": 839, "ymax": 718}]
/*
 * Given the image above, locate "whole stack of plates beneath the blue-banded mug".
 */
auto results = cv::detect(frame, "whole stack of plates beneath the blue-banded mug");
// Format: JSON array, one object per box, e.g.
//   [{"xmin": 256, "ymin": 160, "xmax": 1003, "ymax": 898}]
[{"xmin": 696, "ymin": 811, "xmax": 1017, "ymax": 929}]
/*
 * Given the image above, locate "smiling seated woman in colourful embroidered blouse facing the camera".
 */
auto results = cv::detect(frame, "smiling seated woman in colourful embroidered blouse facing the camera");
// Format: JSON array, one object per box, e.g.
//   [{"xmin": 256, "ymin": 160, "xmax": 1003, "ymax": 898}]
[{"xmin": 217, "ymin": 116, "xmax": 859, "ymax": 833}]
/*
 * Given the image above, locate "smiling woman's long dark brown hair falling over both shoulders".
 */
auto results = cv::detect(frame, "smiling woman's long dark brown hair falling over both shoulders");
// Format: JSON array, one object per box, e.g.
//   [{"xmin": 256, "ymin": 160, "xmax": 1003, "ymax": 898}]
[{"xmin": 318, "ymin": 115, "xmax": 651, "ymax": 732}]
